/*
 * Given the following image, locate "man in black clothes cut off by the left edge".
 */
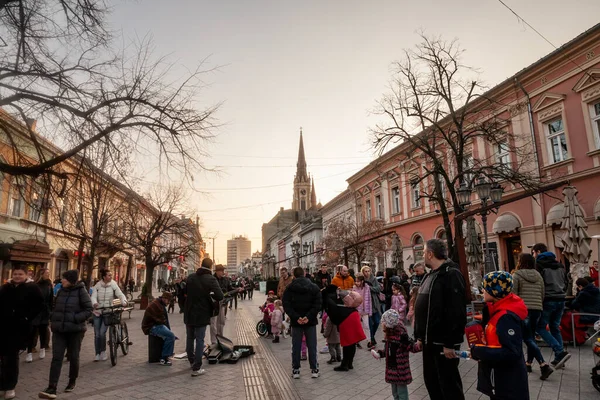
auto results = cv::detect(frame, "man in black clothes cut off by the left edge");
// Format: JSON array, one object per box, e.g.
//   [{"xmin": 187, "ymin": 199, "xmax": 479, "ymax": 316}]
[{"xmin": 0, "ymin": 264, "xmax": 44, "ymax": 399}]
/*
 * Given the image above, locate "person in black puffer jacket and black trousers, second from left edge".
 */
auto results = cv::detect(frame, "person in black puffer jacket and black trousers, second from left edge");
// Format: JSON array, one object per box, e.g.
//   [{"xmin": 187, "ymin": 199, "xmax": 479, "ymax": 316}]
[{"xmin": 39, "ymin": 270, "xmax": 93, "ymax": 399}]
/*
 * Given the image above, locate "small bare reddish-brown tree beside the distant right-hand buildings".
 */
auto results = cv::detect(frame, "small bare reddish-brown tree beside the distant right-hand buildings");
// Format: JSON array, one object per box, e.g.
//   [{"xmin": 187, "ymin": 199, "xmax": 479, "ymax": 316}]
[{"xmin": 322, "ymin": 218, "xmax": 386, "ymax": 267}]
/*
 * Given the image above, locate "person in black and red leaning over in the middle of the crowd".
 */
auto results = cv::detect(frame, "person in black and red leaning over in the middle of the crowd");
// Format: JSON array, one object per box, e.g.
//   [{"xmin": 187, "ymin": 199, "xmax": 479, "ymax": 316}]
[{"xmin": 323, "ymin": 285, "xmax": 367, "ymax": 371}]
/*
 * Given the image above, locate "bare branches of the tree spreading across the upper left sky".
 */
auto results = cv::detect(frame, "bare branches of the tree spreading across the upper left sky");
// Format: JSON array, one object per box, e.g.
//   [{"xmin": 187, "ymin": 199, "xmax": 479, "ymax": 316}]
[{"xmin": 0, "ymin": 0, "xmax": 217, "ymax": 177}]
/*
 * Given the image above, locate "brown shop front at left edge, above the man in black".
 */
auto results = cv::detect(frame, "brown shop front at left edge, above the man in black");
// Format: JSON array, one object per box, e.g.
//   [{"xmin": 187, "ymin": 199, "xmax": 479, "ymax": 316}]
[{"xmin": 0, "ymin": 239, "xmax": 51, "ymax": 283}]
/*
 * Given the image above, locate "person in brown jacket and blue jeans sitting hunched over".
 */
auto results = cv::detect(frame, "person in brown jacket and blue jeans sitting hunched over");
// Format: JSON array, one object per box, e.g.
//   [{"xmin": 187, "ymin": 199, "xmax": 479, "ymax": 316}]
[{"xmin": 142, "ymin": 292, "xmax": 177, "ymax": 367}]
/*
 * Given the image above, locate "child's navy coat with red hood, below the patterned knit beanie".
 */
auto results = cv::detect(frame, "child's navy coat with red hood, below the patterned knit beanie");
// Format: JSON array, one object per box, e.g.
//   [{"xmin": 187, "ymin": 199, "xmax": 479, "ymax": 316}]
[{"xmin": 471, "ymin": 293, "xmax": 529, "ymax": 400}]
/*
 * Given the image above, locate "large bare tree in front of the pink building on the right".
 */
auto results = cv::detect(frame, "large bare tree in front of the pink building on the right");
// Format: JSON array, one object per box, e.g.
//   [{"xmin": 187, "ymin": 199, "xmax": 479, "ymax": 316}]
[{"xmin": 372, "ymin": 35, "xmax": 539, "ymax": 261}]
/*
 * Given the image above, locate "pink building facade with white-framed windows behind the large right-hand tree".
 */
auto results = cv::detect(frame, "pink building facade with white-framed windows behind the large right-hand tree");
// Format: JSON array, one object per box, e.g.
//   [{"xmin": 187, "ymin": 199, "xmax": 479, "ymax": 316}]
[{"xmin": 348, "ymin": 24, "xmax": 600, "ymax": 276}]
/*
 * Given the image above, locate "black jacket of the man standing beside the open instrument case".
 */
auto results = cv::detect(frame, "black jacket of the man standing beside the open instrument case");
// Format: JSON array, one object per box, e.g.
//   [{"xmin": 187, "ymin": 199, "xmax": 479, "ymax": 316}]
[{"xmin": 183, "ymin": 268, "xmax": 223, "ymax": 326}]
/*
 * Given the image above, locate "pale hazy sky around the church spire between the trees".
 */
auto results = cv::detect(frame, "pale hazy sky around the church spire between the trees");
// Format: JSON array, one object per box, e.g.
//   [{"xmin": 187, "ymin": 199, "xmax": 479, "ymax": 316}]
[{"xmin": 109, "ymin": 0, "xmax": 600, "ymax": 263}]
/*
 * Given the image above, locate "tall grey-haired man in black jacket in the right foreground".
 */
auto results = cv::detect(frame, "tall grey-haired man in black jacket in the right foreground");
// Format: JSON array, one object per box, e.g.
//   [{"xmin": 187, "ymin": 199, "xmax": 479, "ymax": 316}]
[{"xmin": 415, "ymin": 239, "xmax": 467, "ymax": 400}]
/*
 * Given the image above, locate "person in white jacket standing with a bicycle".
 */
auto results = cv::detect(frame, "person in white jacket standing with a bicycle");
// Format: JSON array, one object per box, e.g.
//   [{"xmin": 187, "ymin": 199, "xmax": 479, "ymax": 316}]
[{"xmin": 92, "ymin": 269, "xmax": 127, "ymax": 361}]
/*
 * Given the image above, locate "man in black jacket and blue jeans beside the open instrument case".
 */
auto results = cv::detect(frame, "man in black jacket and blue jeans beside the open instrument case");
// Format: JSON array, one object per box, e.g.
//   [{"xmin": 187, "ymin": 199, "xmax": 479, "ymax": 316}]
[{"xmin": 183, "ymin": 258, "xmax": 223, "ymax": 376}]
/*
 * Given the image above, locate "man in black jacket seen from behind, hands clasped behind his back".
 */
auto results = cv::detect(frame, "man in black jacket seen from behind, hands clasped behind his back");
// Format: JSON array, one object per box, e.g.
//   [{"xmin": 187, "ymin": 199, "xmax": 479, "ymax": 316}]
[{"xmin": 283, "ymin": 267, "xmax": 321, "ymax": 379}]
